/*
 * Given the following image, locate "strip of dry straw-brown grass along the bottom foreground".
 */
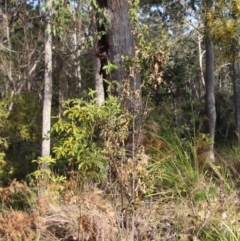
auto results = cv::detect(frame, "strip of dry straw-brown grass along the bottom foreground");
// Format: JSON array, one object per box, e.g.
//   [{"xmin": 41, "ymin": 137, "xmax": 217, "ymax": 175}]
[{"xmin": 0, "ymin": 180, "xmax": 240, "ymax": 241}]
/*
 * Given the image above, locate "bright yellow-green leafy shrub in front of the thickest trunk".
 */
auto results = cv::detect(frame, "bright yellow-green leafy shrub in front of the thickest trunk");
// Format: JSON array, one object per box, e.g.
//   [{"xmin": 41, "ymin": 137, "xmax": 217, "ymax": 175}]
[{"xmin": 52, "ymin": 92, "xmax": 132, "ymax": 181}]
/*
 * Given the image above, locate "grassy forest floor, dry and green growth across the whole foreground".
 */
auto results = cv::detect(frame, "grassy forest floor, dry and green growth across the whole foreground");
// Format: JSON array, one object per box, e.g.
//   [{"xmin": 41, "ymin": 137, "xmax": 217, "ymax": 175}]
[{"xmin": 0, "ymin": 137, "xmax": 240, "ymax": 241}]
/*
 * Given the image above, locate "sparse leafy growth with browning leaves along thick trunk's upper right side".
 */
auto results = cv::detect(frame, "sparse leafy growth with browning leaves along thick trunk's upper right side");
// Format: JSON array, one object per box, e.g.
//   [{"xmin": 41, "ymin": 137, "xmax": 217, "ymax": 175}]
[{"xmin": 123, "ymin": 1, "xmax": 169, "ymax": 92}]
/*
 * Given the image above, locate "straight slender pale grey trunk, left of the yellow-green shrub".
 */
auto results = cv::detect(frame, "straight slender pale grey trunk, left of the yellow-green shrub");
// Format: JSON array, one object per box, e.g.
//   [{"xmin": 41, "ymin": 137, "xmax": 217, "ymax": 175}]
[{"xmin": 42, "ymin": 0, "xmax": 52, "ymax": 160}]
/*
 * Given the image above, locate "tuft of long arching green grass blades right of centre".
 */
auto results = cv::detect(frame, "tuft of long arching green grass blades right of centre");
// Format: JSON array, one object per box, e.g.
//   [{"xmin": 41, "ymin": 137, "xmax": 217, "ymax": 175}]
[{"xmin": 148, "ymin": 136, "xmax": 204, "ymax": 194}]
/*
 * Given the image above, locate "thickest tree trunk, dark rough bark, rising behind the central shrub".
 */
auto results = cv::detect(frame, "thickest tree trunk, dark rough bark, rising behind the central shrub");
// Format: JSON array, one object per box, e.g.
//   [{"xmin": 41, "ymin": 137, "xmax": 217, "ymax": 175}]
[{"xmin": 97, "ymin": 0, "xmax": 142, "ymax": 113}]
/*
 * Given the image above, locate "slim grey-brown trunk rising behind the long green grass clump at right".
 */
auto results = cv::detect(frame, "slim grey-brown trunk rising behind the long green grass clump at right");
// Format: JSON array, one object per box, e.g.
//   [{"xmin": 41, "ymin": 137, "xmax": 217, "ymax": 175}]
[{"xmin": 205, "ymin": 0, "xmax": 216, "ymax": 160}]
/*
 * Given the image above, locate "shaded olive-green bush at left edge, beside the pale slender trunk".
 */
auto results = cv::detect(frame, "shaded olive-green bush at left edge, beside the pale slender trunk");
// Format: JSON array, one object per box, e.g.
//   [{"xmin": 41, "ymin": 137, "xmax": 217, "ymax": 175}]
[{"xmin": 0, "ymin": 93, "xmax": 42, "ymax": 184}]
